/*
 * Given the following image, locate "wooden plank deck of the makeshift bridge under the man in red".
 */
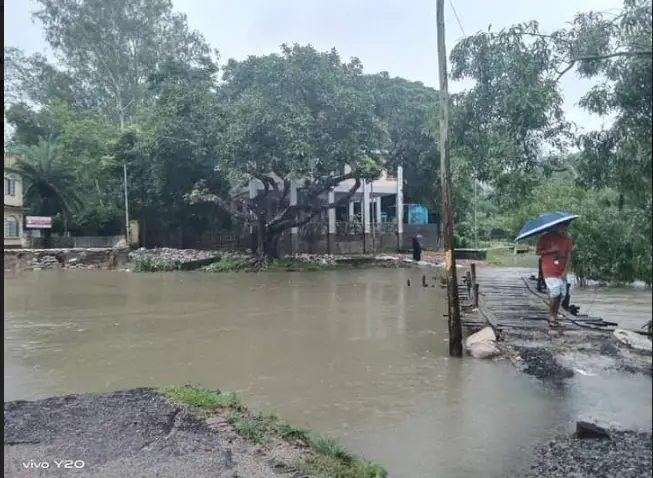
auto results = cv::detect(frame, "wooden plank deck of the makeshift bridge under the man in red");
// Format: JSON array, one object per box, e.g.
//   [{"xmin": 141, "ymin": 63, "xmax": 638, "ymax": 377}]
[{"xmin": 459, "ymin": 264, "xmax": 618, "ymax": 332}]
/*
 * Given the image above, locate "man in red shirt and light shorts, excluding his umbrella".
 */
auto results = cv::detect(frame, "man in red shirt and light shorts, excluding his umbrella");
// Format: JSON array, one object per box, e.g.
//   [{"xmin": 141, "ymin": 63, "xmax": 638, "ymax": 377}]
[{"xmin": 537, "ymin": 223, "xmax": 572, "ymax": 327}]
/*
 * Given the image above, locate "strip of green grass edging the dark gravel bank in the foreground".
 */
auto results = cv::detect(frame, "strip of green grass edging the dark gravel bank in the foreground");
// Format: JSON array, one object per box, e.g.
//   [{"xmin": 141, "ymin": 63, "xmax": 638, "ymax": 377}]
[{"xmin": 160, "ymin": 385, "xmax": 388, "ymax": 478}]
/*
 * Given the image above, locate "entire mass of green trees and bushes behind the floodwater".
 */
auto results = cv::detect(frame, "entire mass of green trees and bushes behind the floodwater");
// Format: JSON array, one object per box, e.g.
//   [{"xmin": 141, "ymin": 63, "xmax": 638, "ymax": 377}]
[{"xmin": 4, "ymin": 0, "xmax": 652, "ymax": 283}]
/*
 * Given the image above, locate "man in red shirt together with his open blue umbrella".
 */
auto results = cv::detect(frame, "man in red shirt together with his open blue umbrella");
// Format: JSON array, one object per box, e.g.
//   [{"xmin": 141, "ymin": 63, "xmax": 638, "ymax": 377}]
[{"xmin": 516, "ymin": 212, "xmax": 578, "ymax": 327}]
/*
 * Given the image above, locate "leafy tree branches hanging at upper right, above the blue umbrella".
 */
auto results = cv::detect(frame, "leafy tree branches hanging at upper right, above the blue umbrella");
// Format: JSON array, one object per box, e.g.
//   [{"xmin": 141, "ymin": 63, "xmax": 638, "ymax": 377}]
[{"xmin": 452, "ymin": 0, "xmax": 652, "ymax": 209}]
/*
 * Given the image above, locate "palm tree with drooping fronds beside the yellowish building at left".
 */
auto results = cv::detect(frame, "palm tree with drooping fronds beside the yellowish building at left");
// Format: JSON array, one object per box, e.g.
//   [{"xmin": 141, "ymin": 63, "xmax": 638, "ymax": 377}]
[{"xmin": 16, "ymin": 138, "xmax": 82, "ymax": 231}]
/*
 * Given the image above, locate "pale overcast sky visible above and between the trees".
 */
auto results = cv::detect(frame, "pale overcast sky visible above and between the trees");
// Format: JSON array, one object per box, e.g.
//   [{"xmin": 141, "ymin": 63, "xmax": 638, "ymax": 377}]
[{"xmin": 4, "ymin": 0, "xmax": 622, "ymax": 129}]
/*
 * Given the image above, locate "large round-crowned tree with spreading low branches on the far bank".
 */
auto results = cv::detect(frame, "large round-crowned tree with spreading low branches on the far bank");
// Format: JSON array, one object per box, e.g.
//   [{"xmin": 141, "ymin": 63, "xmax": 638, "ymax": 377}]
[{"xmin": 192, "ymin": 45, "xmax": 386, "ymax": 257}]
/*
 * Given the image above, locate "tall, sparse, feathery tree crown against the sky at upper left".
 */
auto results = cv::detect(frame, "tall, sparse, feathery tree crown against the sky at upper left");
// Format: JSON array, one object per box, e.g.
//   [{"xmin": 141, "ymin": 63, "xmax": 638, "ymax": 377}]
[{"xmin": 5, "ymin": 0, "xmax": 211, "ymax": 126}]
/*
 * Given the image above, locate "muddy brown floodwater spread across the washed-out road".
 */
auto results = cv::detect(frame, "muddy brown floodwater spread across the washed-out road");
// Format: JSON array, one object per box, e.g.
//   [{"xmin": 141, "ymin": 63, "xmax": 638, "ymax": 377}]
[{"xmin": 4, "ymin": 269, "xmax": 651, "ymax": 478}]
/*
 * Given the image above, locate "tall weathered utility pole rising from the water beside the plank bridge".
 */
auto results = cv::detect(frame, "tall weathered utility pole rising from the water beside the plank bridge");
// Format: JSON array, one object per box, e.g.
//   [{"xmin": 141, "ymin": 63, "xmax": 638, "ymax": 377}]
[{"xmin": 435, "ymin": 0, "xmax": 463, "ymax": 357}]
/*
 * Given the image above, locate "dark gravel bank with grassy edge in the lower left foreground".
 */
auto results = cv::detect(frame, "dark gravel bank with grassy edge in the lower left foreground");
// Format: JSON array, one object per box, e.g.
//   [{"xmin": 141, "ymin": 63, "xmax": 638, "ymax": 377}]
[{"xmin": 4, "ymin": 387, "xmax": 384, "ymax": 478}]
